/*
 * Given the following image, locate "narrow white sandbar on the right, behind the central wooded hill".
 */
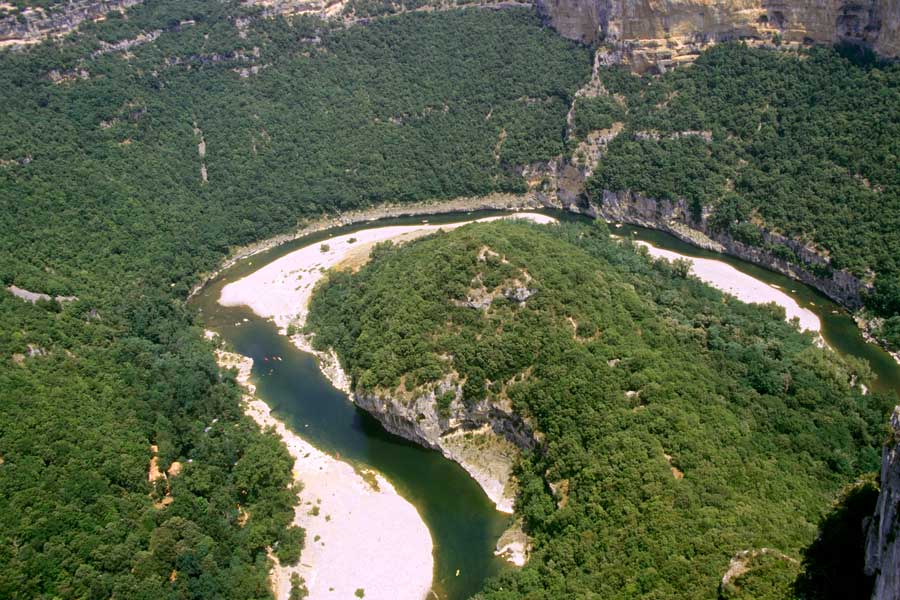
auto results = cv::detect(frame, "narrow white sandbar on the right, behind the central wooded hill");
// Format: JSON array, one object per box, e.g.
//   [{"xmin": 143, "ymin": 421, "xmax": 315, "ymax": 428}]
[{"xmin": 636, "ymin": 241, "xmax": 822, "ymax": 332}]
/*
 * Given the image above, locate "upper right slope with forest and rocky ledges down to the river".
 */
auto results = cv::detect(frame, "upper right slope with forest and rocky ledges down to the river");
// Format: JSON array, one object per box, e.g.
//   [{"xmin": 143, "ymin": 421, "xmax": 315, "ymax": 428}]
[{"xmin": 546, "ymin": 44, "xmax": 900, "ymax": 358}]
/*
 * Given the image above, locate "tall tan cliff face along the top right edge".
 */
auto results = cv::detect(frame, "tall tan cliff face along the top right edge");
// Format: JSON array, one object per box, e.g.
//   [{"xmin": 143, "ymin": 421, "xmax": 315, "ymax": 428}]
[{"xmin": 536, "ymin": 0, "xmax": 900, "ymax": 71}]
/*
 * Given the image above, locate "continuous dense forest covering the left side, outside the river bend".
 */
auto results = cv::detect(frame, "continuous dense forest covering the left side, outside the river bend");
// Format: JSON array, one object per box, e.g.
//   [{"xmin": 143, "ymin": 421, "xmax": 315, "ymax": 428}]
[{"xmin": 0, "ymin": 0, "xmax": 590, "ymax": 600}]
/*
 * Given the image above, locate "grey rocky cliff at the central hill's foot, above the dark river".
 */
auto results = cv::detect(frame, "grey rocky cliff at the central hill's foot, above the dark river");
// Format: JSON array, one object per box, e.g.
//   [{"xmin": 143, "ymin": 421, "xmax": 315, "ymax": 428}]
[{"xmin": 353, "ymin": 376, "xmax": 537, "ymax": 513}]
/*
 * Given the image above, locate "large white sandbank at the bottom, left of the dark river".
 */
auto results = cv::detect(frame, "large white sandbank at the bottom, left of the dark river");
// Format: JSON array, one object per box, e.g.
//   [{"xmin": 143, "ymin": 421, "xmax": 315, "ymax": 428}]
[{"xmin": 216, "ymin": 350, "xmax": 434, "ymax": 600}]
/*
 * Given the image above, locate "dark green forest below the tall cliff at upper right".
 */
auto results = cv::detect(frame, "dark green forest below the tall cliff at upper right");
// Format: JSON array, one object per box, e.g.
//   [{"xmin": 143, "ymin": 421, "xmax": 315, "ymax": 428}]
[{"xmin": 588, "ymin": 44, "xmax": 900, "ymax": 329}]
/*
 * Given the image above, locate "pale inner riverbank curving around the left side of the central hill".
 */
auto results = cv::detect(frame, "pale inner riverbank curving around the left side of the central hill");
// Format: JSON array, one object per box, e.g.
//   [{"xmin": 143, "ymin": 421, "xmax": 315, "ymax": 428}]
[{"xmin": 219, "ymin": 210, "xmax": 556, "ymax": 513}]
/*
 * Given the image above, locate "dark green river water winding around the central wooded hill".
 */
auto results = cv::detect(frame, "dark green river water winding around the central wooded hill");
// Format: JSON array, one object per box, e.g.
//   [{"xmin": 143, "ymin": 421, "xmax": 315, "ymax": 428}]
[{"xmin": 191, "ymin": 211, "xmax": 900, "ymax": 600}]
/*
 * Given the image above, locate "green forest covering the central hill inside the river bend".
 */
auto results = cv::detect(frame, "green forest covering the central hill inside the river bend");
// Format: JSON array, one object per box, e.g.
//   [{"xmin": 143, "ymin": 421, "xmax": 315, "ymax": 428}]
[{"xmin": 308, "ymin": 222, "xmax": 891, "ymax": 600}]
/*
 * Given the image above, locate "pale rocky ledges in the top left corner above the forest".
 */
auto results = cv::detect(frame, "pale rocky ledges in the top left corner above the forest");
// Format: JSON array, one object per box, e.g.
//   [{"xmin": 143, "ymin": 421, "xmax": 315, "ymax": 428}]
[{"xmin": 0, "ymin": 0, "xmax": 144, "ymax": 47}]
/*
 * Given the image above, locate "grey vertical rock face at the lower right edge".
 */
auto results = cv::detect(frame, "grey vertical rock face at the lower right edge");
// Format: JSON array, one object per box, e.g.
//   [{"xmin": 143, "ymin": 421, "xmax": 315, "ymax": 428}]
[{"xmin": 866, "ymin": 406, "xmax": 900, "ymax": 600}]
